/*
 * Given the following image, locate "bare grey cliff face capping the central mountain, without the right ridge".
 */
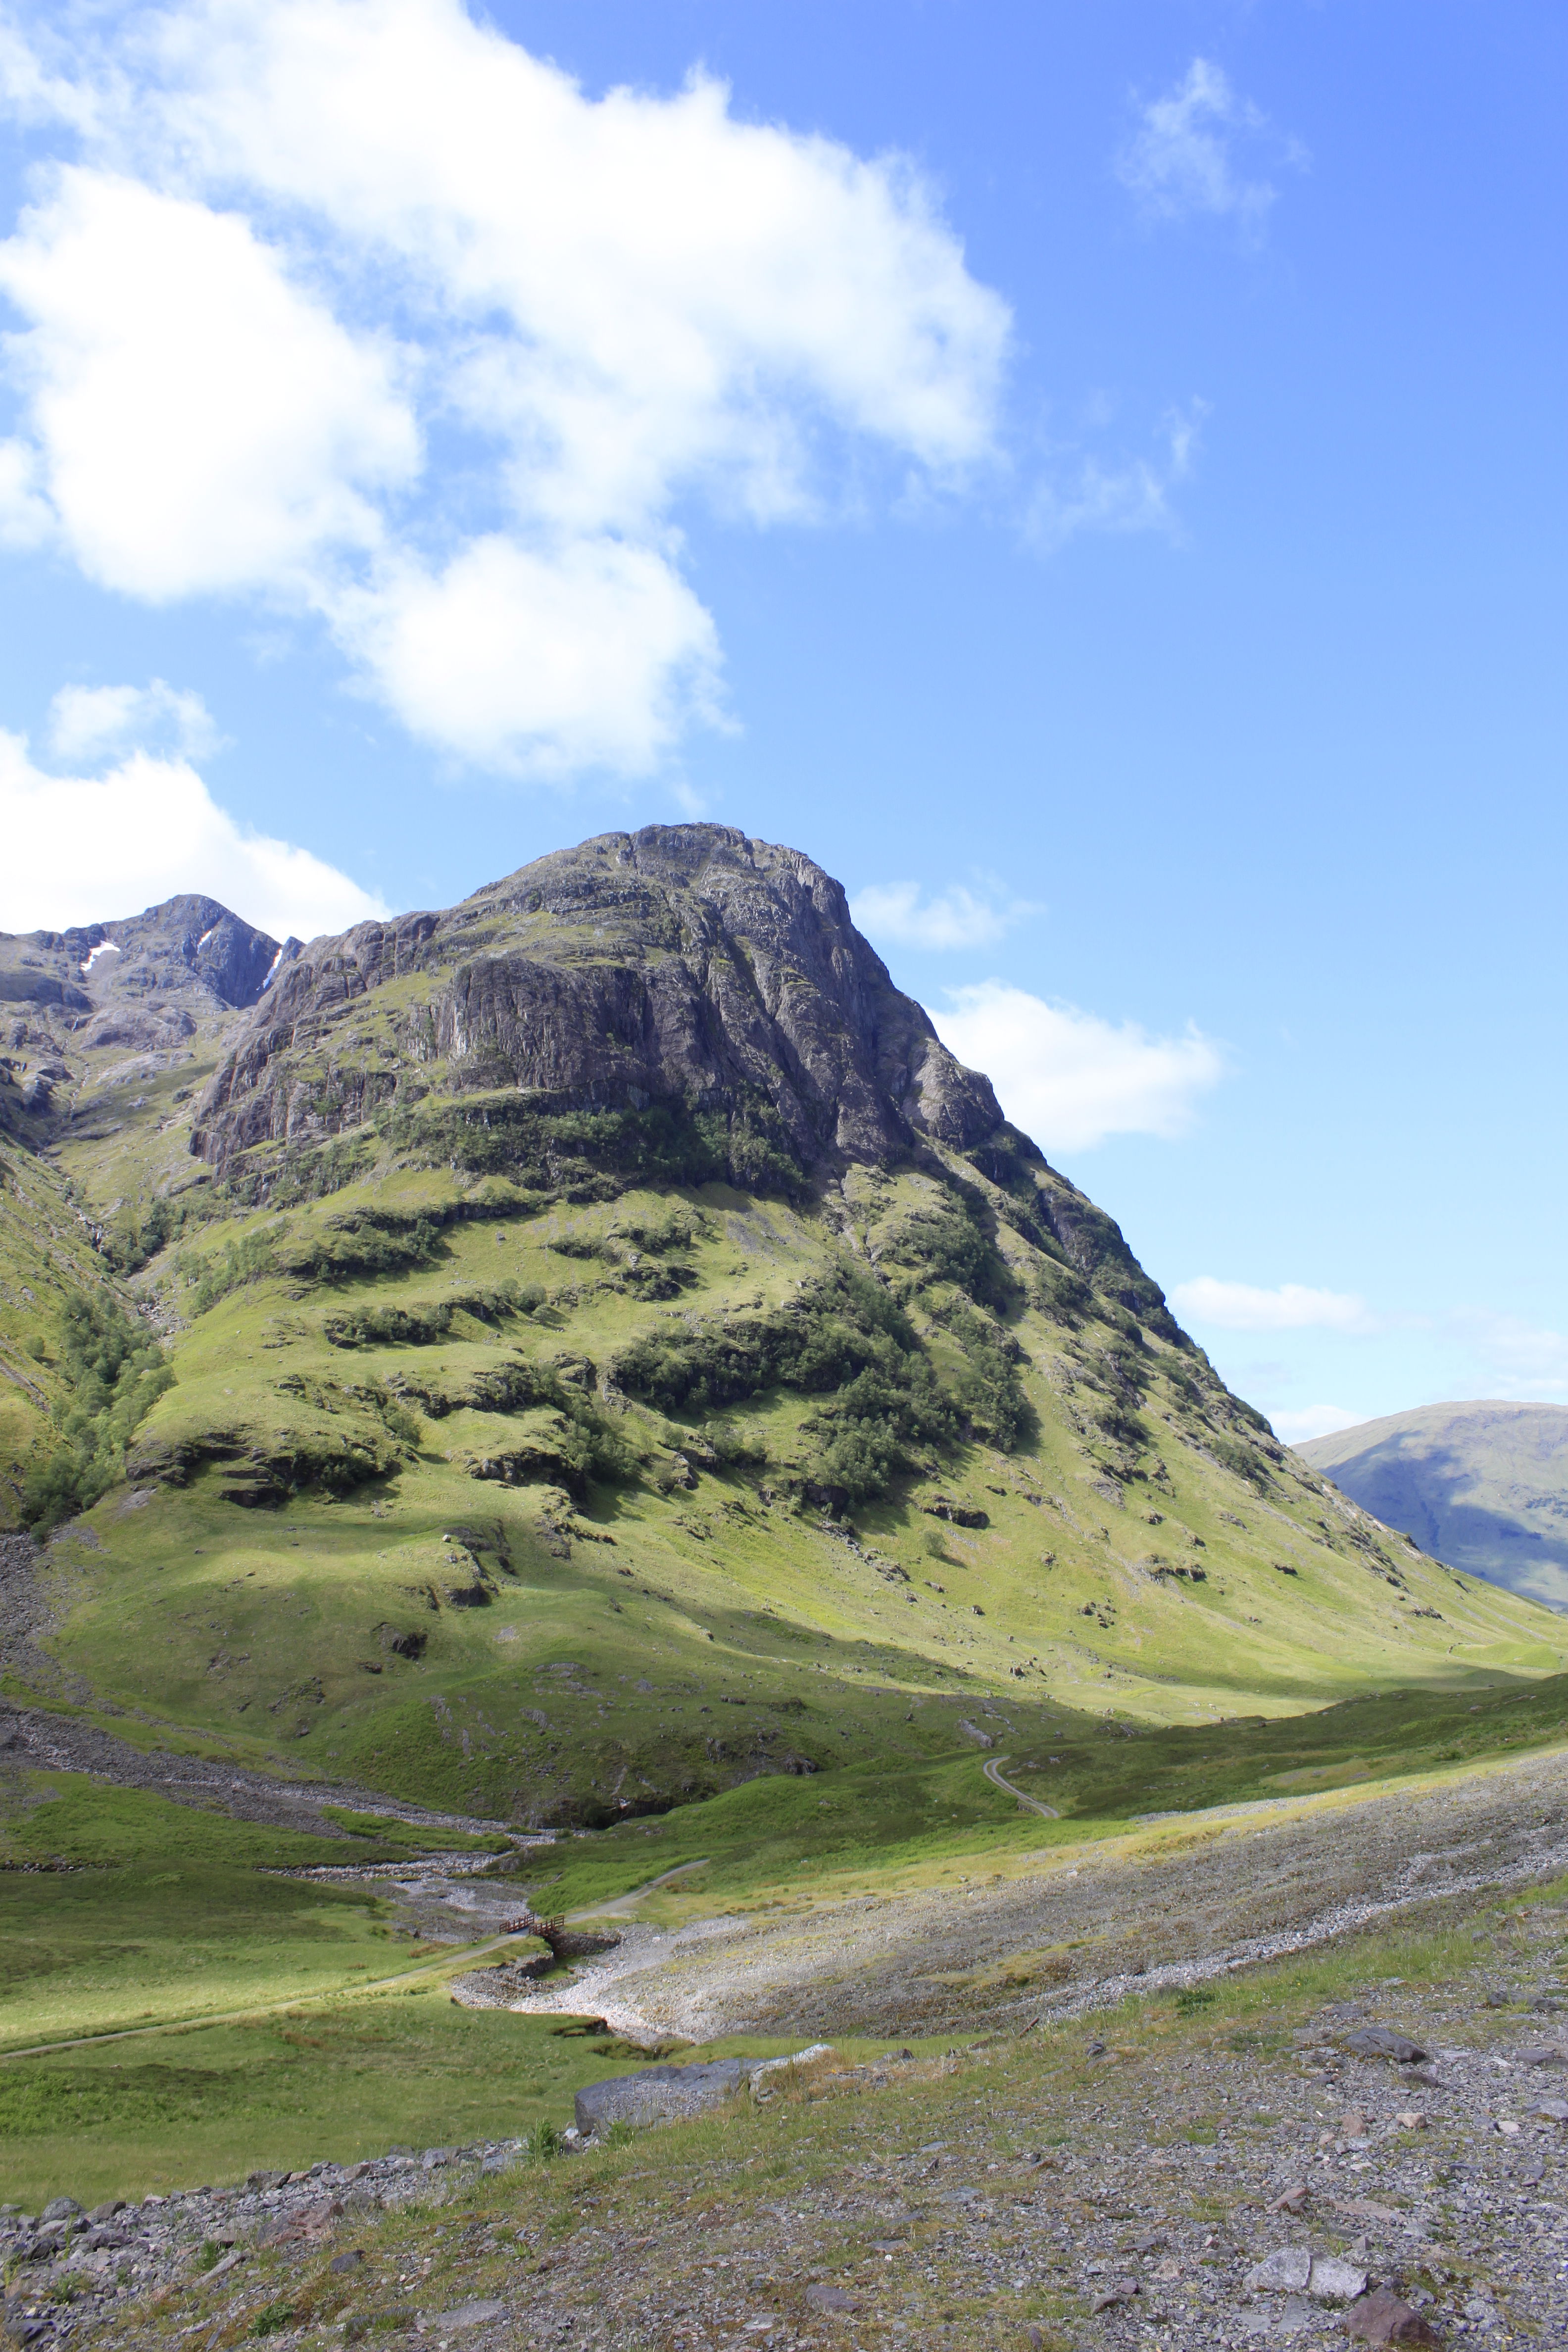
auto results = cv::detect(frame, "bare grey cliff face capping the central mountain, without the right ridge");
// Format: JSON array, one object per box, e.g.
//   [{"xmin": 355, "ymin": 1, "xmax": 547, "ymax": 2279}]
[{"xmin": 195, "ymin": 826, "xmax": 1001, "ymax": 1185}]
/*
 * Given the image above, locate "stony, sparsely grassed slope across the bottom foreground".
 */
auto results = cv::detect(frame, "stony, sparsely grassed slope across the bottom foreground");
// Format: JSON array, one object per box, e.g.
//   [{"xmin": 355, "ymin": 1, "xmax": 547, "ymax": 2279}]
[{"xmin": 18, "ymin": 1882, "xmax": 1568, "ymax": 2352}]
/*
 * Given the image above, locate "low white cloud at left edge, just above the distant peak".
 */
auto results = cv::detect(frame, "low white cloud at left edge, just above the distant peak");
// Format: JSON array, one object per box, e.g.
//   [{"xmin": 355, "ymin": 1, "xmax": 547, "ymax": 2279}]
[{"xmin": 0, "ymin": 732, "xmax": 386, "ymax": 938}]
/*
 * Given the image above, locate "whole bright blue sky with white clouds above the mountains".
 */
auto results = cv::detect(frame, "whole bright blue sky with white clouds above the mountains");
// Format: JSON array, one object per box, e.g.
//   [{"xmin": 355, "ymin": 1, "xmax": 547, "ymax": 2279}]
[{"xmin": 0, "ymin": 0, "xmax": 1568, "ymax": 1437}]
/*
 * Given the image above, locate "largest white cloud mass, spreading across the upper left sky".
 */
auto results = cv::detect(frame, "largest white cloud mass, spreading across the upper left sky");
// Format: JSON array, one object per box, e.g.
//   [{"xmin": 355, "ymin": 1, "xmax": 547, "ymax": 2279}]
[{"xmin": 0, "ymin": 0, "xmax": 1011, "ymax": 774}]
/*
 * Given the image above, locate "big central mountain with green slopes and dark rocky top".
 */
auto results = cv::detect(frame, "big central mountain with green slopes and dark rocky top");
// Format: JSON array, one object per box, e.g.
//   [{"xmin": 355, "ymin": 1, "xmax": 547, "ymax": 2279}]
[{"xmin": 0, "ymin": 826, "xmax": 1564, "ymax": 1823}]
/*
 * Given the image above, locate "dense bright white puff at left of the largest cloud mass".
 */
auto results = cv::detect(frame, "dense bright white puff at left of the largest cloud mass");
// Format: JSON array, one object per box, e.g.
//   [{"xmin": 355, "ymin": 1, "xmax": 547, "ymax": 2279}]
[{"xmin": 0, "ymin": 167, "xmax": 418, "ymax": 602}]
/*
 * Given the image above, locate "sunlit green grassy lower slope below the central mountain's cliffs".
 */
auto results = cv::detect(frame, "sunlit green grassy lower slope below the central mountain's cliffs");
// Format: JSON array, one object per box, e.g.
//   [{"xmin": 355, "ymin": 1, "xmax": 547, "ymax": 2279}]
[{"xmin": 9, "ymin": 1128, "xmax": 1564, "ymax": 1820}]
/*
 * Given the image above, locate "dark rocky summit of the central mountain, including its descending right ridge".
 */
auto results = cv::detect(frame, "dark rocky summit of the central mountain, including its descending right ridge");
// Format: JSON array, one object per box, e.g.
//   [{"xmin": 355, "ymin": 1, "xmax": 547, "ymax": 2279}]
[{"xmin": 193, "ymin": 826, "xmax": 1176, "ymax": 1329}]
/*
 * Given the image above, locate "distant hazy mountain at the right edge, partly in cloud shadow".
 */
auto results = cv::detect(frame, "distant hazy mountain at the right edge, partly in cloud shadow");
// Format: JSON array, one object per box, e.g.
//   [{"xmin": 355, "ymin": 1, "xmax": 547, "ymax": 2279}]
[{"xmin": 1300, "ymin": 1402, "xmax": 1568, "ymax": 1609}]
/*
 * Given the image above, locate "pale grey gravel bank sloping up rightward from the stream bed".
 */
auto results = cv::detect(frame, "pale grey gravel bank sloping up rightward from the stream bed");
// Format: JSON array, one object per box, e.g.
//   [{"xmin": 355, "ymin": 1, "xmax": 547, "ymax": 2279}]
[{"xmin": 503, "ymin": 1752, "xmax": 1568, "ymax": 2042}]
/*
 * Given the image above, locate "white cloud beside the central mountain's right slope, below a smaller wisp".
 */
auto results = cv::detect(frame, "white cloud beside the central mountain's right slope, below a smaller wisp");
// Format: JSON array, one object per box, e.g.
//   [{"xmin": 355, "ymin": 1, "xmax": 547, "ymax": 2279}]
[{"xmin": 931, "ymin": 981, "xmax": 1225, "ymax": 1152}]
